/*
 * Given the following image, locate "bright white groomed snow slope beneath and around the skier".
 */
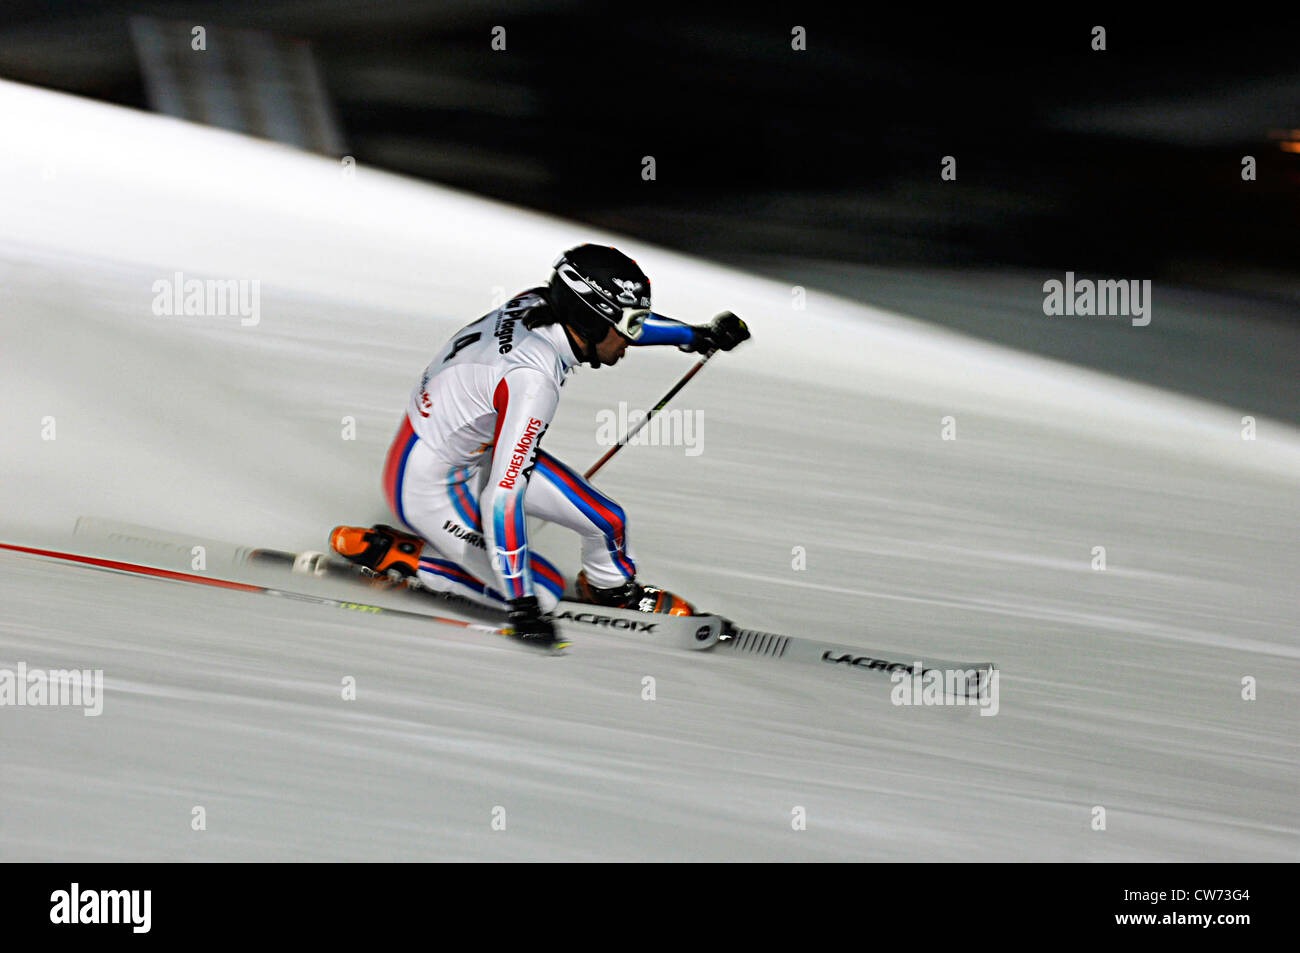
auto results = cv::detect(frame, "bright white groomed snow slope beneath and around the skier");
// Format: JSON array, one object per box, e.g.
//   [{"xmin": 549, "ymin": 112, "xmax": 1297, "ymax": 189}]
[{"xmin": 0, "ymin": 83, "xmax": 1300, "ymax": 861}]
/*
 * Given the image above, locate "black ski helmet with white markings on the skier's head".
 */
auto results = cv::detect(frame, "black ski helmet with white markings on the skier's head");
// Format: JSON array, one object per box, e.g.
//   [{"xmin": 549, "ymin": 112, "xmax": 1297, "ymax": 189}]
[{"xmin": 549, "ymin": 244, "xmax": 650, "ymax": 343}]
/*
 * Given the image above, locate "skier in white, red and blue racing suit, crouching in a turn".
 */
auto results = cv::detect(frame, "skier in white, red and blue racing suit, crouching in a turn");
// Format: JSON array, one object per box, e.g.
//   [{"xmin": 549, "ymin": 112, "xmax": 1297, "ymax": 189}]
[{"xmin": 330, "ymin": 244, "xmax": 749, "ymax": 645}]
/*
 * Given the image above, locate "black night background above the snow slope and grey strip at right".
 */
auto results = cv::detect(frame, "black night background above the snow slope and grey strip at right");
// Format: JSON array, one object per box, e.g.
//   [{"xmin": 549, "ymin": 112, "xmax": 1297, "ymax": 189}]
[{"xmin": 0, "ymin": 0, "xmax": 1300, "ymax": 289}]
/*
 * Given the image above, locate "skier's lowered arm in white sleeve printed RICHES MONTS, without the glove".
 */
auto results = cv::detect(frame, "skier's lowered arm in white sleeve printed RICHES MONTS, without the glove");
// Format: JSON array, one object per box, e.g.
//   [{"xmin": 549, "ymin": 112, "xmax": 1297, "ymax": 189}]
[{"xmin": 478, "ymin": 367, "xmax": 559, "ymax": 599}]
